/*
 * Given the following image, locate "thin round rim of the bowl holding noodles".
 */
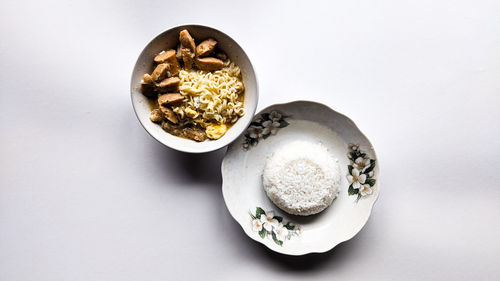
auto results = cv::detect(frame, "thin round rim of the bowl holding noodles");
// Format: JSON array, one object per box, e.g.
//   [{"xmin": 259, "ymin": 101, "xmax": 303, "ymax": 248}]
[{"xmin": 130, "ymin": 23, "xmax": 259, "ymax": 153}]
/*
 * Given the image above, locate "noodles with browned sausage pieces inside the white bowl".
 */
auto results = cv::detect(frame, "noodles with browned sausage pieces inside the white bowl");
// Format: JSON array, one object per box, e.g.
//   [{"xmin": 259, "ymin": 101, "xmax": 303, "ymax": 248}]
[{"xmin": 141, "ymin": 30, "xmax": 245, "ymax": 142}]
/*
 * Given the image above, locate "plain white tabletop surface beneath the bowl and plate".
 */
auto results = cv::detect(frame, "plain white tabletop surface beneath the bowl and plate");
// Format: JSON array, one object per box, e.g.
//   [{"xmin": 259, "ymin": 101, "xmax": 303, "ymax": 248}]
[{"xmin": 0, "ymin": 0, "xmax": 500, "ymax": 281}]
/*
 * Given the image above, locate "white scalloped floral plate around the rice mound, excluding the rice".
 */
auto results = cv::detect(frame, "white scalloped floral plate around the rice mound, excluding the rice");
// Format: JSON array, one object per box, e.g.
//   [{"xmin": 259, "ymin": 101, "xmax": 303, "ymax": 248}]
[{"xmin": 222, "ymin": 101, "xmax": 379, "ymax": 255}]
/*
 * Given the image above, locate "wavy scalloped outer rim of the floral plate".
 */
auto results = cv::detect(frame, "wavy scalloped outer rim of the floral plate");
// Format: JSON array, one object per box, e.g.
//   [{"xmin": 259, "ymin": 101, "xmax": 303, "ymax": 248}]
[{"xmin": 221, "ymin": 100, "xmax": 381, "ymax": 256}]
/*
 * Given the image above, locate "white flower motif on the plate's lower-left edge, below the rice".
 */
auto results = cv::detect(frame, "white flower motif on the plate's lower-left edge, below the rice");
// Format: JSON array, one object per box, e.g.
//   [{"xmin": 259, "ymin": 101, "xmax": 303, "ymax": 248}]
[{"xmin": 250, "ymin": 207, "xmax": 302, "ymax": 246}]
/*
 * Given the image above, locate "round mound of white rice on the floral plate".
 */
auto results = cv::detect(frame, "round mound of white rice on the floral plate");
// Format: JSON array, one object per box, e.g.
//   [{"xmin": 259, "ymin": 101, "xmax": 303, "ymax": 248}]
[{"xmin": 262, "ymin": 141, "xmax": 340, "ymax": 216}]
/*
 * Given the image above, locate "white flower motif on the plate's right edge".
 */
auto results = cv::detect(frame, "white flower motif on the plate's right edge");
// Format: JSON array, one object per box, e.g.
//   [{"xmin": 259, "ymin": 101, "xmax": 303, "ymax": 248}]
[{"xmin": 347, "ymin": 144, "xmax": 377, "ymax": 202}]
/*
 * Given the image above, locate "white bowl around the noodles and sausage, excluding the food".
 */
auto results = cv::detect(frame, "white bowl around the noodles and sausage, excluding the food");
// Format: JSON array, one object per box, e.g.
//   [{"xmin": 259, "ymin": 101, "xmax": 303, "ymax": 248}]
[{"xmin": 130, "ymin": 25, "xmax": 259, "ymax": 153}]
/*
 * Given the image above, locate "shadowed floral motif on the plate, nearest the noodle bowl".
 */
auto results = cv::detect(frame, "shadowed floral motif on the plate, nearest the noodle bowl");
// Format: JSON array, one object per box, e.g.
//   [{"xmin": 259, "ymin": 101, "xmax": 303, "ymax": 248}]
[{"xmin": 243, "ymin": 110, "xmax": 290, "ymax": 150}]
